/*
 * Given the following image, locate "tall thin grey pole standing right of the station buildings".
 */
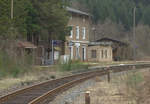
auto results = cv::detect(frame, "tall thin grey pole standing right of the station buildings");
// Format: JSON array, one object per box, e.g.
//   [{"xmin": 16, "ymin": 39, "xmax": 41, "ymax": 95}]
[{"xmin": 133, "ymin": 7, "xmax": 136, "ymax": 61}]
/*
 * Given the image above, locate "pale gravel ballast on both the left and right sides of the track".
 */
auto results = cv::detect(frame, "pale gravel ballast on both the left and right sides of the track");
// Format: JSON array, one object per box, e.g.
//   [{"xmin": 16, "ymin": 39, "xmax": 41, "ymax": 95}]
[{"xmin": 0, "ymin": 67, "xmax": 149, "ymax": 104}]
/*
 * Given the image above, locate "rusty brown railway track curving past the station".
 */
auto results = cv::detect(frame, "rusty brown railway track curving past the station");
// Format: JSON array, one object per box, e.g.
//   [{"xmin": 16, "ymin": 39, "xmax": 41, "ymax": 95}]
[{"xmin": 0, "ymin": 64, "xmax": 150, "ymax": 104}]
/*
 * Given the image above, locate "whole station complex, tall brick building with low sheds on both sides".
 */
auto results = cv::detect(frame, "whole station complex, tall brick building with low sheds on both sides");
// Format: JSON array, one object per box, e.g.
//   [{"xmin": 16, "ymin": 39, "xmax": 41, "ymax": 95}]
[{"xmin": 22, "ymin": 7, "xmax": 128, "ymax": 65}]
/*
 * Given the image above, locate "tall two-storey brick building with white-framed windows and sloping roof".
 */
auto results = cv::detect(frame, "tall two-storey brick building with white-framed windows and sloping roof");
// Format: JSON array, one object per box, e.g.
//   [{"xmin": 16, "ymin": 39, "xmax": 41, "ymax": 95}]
[{"xmin": 65, "ymin": 7, "xmax": 91, "ymax": 61}]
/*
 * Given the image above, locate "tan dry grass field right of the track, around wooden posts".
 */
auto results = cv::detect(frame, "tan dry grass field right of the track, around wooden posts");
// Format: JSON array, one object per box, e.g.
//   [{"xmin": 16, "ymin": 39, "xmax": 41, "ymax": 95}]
[{"xmin": 73, "ymin": 70, "xmax": 150, "ymax": 104}]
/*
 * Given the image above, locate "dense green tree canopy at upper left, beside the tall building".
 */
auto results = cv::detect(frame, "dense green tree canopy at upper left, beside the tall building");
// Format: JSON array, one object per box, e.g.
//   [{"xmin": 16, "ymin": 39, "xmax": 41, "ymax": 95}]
[{"xmin": 0, "ymin": 0, "xmax": 68, "ymax": 39}]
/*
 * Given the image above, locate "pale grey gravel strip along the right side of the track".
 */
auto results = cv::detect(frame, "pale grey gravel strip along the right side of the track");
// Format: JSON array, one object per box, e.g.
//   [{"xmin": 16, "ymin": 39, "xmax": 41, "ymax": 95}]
[{"xmin": 49, "ymin": 69, "xmax": 150, "ymax": 104}]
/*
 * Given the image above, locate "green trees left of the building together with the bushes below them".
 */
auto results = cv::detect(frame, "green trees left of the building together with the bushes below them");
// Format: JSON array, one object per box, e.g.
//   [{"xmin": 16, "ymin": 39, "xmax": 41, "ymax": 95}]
[{"xmin": 0, "ymin": 0, "xmax": 69, "ymax": 78}]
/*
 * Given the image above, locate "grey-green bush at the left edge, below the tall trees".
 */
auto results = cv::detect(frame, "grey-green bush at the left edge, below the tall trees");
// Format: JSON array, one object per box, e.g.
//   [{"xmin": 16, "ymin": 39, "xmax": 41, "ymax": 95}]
[{"xmin": 0, "ymin": 51, "xmax": 32, "ymax": 78}]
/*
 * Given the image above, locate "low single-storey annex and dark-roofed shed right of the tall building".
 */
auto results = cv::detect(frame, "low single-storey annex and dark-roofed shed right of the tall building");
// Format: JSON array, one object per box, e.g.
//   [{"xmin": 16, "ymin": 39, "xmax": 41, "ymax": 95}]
[{"xmin": 88, "ymin": 37, "xmax": 131, "ymax": 62}]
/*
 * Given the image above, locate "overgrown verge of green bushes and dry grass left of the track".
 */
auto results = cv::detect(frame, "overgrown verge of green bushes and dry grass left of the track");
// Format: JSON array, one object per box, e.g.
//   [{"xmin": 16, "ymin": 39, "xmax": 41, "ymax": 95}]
[{"xmin": 0, "ymin": 57, "xmax": 87, "ymax": 90}]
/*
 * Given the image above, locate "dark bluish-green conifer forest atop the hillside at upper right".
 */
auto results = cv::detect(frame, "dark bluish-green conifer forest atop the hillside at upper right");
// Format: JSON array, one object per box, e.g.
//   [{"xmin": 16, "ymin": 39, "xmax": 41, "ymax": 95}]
[{"xmin": 78, "ymin": 0, "xmax": 150, "ymax": 29}]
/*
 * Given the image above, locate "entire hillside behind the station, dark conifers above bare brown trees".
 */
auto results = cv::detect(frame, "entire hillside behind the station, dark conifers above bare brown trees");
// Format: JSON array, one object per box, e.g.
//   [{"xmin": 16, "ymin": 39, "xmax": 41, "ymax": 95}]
[{"xmin": 72, "ymin": 0, "xmax": 150, "ymax": 57}]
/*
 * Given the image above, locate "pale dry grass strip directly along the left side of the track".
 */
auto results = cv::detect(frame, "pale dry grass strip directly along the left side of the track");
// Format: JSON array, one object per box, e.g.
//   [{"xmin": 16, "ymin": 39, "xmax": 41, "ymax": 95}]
[{"xmin": 0, "ymin": 66, "xmax": 70, "ymax": 96}]
